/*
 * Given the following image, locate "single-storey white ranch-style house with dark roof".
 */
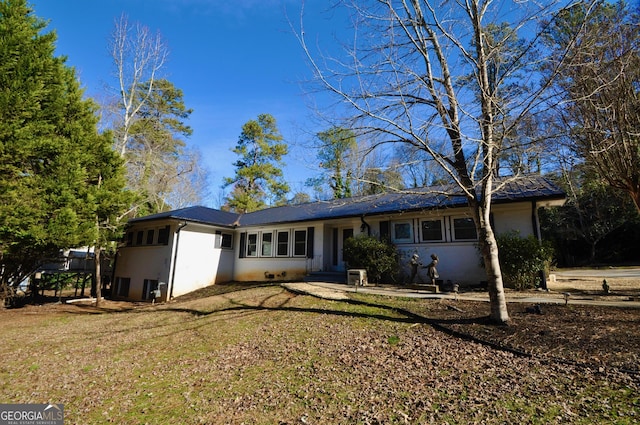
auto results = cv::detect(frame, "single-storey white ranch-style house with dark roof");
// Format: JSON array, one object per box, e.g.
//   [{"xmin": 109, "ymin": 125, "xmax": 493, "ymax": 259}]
[{"xmin": 112, "ymin": 175, "xmax": 565, "ymax": 301}]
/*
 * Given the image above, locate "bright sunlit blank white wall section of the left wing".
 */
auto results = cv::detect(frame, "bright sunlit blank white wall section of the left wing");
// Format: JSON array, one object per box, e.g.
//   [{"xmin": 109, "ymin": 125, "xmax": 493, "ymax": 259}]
[{"xmin": 171, "ymin": 223, "xmax": 234, "ymax": 297}]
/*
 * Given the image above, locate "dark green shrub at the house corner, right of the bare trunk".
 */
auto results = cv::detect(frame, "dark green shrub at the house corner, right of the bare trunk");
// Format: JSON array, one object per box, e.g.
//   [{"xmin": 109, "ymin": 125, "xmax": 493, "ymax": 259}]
[{"xmin": 496, "ymin": 232, "xmax": 553, "ymax": 289}]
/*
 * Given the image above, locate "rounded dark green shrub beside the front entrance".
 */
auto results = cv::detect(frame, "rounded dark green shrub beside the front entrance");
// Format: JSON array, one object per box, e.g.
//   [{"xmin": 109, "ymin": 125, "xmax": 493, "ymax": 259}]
[{"xmin": 343, "ymin": 235, "xmax": 398, "ymax": 283}]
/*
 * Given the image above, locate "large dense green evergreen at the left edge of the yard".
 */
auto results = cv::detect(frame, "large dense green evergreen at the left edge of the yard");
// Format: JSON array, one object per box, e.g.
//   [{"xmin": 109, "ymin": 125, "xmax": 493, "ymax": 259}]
[{"xmin": 0, "ymin": 0, "xmax": 126, "ymax": 299}]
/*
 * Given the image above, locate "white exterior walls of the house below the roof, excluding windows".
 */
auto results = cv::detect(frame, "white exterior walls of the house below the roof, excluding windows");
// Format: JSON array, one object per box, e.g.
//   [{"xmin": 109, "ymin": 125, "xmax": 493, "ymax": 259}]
[{"xmin": 113, "ymin": 186, "xmax": 556, "ymax": 300}]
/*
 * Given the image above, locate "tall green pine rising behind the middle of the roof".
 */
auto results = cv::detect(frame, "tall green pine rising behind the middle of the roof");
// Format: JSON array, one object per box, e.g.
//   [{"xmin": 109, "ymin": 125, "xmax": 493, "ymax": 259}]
[{"xmin": 225, "ymin": 114, "xmax": 289, "ymax": 213}]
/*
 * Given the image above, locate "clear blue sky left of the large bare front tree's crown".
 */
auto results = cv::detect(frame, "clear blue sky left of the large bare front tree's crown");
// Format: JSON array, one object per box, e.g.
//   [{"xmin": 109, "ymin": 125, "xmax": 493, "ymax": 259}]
[{"xmin": 30, "ymin": 0, "xmax": 348, "ymax": 206}]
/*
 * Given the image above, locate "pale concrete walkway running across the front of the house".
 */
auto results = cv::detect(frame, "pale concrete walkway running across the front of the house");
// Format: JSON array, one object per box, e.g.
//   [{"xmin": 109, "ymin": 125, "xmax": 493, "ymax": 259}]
[{"xmin": 282, "ymin": 282, "xmax": 640, "ymax": 308}]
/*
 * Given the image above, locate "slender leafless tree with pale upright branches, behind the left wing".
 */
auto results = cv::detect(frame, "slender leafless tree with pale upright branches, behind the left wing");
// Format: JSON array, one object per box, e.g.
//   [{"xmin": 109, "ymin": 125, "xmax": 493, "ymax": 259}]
[{"xmin": 109, "ymin": 14, "xmax": 169, "ymax": 157}]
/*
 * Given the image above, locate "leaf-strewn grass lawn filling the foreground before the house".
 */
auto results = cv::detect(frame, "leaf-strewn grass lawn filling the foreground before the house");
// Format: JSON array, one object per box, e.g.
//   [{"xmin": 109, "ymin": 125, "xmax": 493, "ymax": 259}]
[{"xmin": 0, "ymin": 286, "xmax": 640, "ymax": 424}]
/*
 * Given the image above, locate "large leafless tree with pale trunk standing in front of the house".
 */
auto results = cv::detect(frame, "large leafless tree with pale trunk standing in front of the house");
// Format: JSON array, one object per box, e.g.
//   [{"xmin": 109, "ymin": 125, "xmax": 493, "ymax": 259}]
[{"xmin": 298, "ymin": 0, "xmax": 592, "ymax": 323}]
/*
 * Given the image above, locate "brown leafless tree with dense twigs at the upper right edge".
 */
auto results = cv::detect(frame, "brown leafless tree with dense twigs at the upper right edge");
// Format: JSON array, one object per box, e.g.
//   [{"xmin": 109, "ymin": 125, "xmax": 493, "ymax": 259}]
[{"xmin": 548, "ymin": 1, "xmax": 640, "ymax": 213}]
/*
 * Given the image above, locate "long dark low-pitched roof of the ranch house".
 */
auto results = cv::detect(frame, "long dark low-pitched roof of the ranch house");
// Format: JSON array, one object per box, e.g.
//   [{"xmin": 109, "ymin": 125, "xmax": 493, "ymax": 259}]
[{"xmin": 131, "ymin": 176, "xmax": 566, "ymax": 227}]
